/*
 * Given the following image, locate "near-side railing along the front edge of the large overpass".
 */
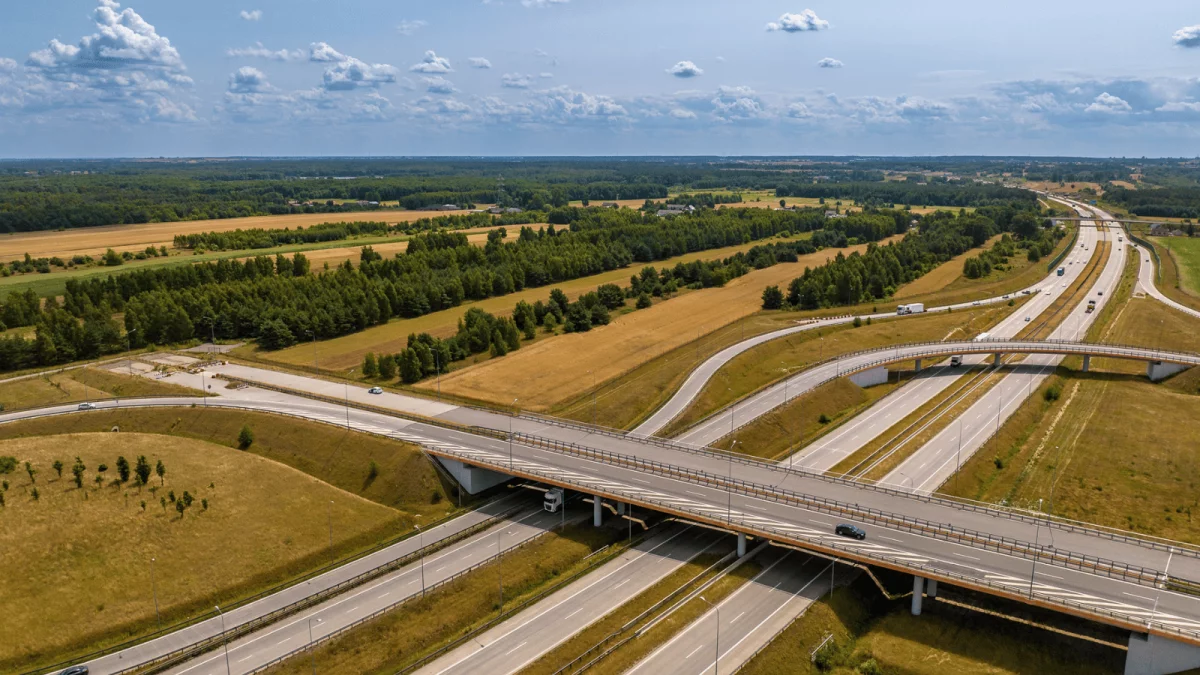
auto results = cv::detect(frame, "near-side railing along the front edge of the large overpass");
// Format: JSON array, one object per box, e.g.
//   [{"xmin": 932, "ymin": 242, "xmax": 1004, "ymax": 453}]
[{"xmin": 431, "ymin": 448, "xmax": 1200, "ymax": 644}]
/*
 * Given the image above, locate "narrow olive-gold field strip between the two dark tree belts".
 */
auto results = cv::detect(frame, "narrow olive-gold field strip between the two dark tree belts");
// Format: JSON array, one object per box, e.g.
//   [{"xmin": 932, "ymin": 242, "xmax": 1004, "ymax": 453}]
[{"xmin": 257, "ymin": 233, "xmax": 824, "ymax": 370}]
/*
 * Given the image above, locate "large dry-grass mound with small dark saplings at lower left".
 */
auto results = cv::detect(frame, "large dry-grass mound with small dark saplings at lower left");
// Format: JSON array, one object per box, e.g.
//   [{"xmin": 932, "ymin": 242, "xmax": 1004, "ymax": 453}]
[{"xmin": 0, "ymin": 432, "xmax": 397, "ymax": 671}]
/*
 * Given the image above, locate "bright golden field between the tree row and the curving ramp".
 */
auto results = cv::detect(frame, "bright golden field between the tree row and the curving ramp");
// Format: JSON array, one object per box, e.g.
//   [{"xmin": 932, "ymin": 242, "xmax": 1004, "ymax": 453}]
[{"xmin": 417, "ymin": 239, "xmax": 897, "ymax": 411}]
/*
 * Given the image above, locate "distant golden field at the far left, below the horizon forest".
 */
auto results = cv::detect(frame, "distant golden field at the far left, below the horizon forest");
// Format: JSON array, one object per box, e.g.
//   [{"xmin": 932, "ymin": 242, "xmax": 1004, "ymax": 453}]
[{"xmin": 0, "ymin": 211, "xmax": 487, "ymax": 261}]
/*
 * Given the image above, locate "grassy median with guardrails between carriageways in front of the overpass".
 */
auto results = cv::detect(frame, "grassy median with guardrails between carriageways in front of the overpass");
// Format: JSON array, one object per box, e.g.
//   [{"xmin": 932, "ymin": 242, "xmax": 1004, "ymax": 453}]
[{"xmin": 518, "ymin": 543, "xmax": 732, "ymax": 675}]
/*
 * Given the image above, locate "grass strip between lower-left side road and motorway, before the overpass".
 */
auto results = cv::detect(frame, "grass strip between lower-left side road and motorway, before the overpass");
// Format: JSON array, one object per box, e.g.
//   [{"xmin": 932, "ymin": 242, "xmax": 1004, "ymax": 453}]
[{"xmin": 258, "ymin": 522, "xmax": 626, "ymax": 675}]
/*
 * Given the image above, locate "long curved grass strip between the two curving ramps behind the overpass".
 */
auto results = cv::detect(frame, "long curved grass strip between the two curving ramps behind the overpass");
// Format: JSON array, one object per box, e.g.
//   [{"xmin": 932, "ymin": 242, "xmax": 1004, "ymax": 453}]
[{"xmin": 661, "ymin": 304, "xmax": 1013, "ymax": 436}]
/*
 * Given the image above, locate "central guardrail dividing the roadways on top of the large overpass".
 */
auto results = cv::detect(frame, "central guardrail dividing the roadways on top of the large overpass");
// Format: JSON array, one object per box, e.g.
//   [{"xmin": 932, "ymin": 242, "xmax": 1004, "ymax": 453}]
[{"xmin": 512, "ymin": 432, "xmax": 1164, "ymax": 586}]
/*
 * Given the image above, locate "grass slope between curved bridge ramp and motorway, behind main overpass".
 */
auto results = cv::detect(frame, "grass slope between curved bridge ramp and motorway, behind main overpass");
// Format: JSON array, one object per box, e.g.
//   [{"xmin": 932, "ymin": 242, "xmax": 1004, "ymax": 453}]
[{"xmin": 712, "ymin": 371, "xmax": 902, "ymax": 461}]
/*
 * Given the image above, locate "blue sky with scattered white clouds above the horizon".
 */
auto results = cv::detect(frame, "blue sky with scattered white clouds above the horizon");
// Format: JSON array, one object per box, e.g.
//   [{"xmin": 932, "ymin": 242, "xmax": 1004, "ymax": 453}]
[{"xmin": 0, "ymin": 0, "xmax": 1200, "ymax": 157}]
